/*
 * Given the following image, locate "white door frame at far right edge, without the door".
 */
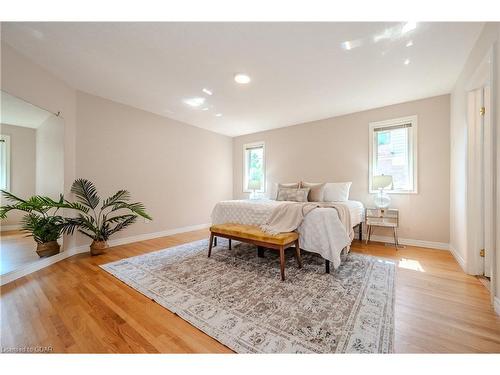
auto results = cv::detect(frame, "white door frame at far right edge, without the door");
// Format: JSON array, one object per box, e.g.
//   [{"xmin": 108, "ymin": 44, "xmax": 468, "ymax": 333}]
[{"xmin": 465, "ymin": 43, "xmax": 498, "ymax": 297}]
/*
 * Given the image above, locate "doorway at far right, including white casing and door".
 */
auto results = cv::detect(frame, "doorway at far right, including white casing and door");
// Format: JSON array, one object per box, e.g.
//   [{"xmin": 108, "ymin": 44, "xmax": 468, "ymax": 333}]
[{"xmin": 466, "ymin": 46, "xmax": 498, "ymax": 301}]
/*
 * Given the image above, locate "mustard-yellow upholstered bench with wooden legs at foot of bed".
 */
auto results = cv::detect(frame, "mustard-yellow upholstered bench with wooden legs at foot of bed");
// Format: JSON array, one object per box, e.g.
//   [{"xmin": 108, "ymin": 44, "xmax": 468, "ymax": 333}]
[{"xmin": 208, "ymin": 223, "xmax": 302, "ymax": 280}]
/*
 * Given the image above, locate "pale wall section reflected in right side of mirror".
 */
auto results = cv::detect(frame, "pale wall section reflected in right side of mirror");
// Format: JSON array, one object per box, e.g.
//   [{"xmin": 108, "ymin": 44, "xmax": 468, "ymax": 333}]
[{"xmin": 36, "ymin": 115, "xmax": 64, "ymax": 199}]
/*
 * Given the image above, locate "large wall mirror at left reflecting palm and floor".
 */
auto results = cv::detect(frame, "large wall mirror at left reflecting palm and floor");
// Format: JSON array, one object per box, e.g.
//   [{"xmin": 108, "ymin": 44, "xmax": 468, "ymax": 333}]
[{"xmin": 0, "ymin": 91, "xmax": 64, "ymax": 276}]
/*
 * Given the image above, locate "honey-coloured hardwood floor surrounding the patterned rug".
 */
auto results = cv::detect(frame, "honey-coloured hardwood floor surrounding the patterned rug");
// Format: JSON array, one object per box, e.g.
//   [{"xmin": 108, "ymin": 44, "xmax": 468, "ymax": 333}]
[{"xmin": 0, "ymin": 230, "xmax": 500, "ymax": 353}]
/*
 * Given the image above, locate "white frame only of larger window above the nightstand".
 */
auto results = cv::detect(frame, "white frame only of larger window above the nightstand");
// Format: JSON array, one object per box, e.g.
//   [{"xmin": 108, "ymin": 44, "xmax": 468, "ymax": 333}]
[{"xmin": 368, "ymin": 115, "xmax": 418, "ymax": 194}]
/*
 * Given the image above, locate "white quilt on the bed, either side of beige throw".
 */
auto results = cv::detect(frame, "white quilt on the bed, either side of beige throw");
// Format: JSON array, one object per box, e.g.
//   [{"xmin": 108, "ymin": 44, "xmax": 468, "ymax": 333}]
[{"xmin": 212, "ymin": 200, "xmax": 363, "ymax": 268}]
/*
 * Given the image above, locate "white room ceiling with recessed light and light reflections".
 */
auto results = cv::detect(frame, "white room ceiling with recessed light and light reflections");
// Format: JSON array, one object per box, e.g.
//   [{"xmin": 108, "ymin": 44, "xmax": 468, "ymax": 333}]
[{"xmin": 2, "ymin": 22, "xmax": 483, "ymax": 136}]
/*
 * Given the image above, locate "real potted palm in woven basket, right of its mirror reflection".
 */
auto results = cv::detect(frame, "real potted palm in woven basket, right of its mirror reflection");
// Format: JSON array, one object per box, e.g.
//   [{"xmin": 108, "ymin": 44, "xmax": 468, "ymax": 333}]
[{"xmin": 63, "ymin": 179, "xmax": 152, "ymax": 255}]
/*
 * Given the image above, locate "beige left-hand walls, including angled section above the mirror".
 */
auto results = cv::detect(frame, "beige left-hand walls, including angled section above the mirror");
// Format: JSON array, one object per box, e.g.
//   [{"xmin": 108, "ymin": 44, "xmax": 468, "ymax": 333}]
[{"xmin": 0, "ymin": 42, "xmax": 232, "ymax": 248}]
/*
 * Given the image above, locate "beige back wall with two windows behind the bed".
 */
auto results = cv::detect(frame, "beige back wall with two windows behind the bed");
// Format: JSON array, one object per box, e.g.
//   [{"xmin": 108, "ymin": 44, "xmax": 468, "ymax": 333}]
[{"xmin": 233, "ymin": 95, "xmax": 450, "ymax": 246}]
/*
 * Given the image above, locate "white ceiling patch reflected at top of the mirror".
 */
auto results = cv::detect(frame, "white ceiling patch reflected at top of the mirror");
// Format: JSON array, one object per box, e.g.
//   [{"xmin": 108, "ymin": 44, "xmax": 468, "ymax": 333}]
[{"xmin": 0, "ymin": 91, "xmax": 52, "ymax": 129}]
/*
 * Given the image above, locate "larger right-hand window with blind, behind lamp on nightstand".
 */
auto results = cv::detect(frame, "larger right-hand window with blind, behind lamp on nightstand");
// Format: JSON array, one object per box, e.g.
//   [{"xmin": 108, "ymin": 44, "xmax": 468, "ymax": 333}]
[{"xmin": 369, "ymin": 116, "xmax": 417, "ymax": 193}]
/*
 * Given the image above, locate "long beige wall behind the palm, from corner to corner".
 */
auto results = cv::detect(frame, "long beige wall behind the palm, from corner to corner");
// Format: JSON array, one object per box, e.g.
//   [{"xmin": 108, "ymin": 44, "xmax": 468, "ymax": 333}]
[{"xmin": 76, "ymin": 92, "xmax": 232, "ymax": 247}]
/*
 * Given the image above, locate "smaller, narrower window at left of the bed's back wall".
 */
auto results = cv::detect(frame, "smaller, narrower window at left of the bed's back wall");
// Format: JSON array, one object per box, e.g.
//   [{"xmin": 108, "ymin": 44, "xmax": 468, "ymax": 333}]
[{"xmin": 243, "ymin": 142, "xmax": 266, "ymax": 193}]
